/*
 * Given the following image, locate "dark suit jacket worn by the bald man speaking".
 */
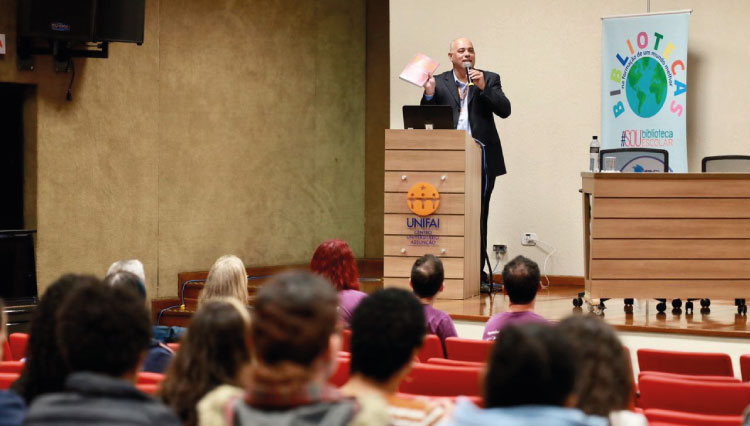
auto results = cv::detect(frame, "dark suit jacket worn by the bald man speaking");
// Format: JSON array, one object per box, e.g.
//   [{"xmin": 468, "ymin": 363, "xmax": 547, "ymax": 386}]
[{"xmin": 421, "ymin": 69, "xmax": 510, "ymax": 176}]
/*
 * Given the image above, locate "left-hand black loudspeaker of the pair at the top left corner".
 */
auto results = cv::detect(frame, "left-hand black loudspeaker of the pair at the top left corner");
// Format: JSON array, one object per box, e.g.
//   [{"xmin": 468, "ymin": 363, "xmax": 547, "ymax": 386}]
[{"xmin": 18, "ymin": 0, "xmax": 96, "ymax": 42}]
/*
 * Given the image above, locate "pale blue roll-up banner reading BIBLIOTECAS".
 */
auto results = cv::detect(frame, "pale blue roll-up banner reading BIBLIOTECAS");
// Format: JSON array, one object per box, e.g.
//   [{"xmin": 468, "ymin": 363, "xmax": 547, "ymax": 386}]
[{"xmin": 602, "ymin": 10, "xmax": 691, "ymax": 173}]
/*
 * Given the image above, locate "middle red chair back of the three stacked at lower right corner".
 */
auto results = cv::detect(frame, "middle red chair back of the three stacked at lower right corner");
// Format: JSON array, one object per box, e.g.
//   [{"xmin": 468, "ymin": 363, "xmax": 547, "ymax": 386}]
[{"xmin": 638, "ymin": 375, "xmax": 750, "ymax": 416}]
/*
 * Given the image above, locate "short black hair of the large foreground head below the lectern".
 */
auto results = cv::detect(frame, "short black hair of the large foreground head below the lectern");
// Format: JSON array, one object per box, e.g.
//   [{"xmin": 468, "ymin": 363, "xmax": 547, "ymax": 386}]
[{"xmin": 351, "ymin": 288, "xmax": 427, "ymax": 383}]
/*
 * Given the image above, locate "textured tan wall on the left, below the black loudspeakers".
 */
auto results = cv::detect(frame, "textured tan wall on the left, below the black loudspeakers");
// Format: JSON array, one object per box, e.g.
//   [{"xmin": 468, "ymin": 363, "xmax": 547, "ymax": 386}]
[{"xmin": 0, "ymin": 0, "xmax": 365, "ymax": 296}]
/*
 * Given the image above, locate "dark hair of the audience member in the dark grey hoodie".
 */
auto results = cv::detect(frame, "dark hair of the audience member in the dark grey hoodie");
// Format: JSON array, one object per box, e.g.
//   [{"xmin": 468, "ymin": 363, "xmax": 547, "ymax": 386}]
[{"xmin": 56, "ymin": 282, "xmax": 151, "ymax": 377}]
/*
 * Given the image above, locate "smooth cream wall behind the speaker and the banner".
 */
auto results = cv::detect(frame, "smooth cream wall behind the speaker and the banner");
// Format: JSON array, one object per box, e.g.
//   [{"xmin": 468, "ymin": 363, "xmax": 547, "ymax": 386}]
[{"xmin": 390, "ymin": 0, "xmax": 750, "ymax": 275}]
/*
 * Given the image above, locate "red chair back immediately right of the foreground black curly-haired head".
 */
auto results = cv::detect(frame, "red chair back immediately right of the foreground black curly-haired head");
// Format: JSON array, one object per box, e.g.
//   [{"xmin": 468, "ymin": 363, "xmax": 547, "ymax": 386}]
[{"xmin": 398, "ymin": 363, "xmax": 482, "ymax": 396}]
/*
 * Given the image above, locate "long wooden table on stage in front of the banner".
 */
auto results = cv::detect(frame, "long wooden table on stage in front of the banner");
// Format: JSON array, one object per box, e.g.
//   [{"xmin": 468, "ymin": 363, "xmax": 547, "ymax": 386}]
[{"xmin": 581, "ymin": 172, "xmax": 750, "ymax": 299}]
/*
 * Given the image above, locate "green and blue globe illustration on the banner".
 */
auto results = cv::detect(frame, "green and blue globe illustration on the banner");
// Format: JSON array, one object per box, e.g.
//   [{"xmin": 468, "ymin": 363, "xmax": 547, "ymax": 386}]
[{"xmin": 625, "ymin": 57, "xmax": 667, "ymax": 118}]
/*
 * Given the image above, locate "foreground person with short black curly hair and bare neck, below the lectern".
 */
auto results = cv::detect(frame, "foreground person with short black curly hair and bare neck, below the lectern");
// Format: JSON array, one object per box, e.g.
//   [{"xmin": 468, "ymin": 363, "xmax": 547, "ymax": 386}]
[{"xmin": 341, "ymin": 288, "xmax": 445, "ymax": 425}]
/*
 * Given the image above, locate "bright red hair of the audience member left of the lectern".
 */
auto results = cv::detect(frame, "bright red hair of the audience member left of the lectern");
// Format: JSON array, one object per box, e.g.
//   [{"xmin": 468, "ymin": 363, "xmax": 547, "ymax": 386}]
[{"xmin": 310, "ymin": 240, "xmax": 359, "ymax": 291}]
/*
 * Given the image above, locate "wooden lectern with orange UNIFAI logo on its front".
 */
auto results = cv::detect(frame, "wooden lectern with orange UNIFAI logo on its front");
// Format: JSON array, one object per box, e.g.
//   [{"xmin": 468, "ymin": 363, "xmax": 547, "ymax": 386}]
[{"xmin": 383, "ymin": 130, "xmax": 482, "ymax": 299}]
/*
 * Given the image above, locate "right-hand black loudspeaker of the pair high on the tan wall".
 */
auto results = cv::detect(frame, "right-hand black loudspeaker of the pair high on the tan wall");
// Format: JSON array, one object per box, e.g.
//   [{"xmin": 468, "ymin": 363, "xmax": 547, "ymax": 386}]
[{"xmin": 94, "ymin": 0, "xmax": 146, "ymax": 44}]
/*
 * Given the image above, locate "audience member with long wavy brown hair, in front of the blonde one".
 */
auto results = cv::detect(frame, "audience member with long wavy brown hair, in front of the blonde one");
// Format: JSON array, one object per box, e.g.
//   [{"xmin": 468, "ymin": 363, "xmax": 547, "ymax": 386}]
[{"xmin": 161, "ymin": 298, "xmax": 250, "ymax": 426}]
